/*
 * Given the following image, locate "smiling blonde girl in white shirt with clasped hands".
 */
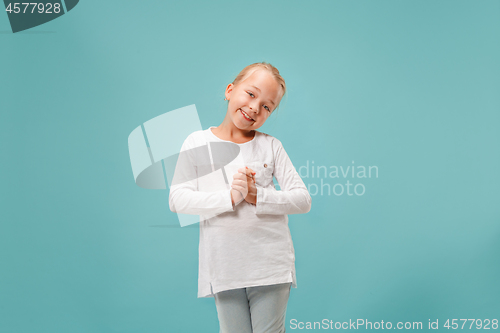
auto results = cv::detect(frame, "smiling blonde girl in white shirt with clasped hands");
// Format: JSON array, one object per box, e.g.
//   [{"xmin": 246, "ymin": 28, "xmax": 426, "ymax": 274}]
[{"xmin": 169, "ymin": 62, "xmax": 311, "ymax": 333}]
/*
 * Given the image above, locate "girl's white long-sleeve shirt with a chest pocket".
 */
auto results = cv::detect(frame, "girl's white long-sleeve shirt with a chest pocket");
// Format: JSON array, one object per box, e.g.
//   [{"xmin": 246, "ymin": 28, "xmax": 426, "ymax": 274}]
[{"xmin": 169, "ymin": 127, "xmax": 311, "ymax": 297}]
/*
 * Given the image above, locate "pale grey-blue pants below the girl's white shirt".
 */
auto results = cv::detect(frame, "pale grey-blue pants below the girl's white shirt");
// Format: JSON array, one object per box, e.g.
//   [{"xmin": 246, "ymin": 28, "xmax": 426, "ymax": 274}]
[{"xmin": 214, "ymin": 283, "xmax": 292, "ymax": 333}]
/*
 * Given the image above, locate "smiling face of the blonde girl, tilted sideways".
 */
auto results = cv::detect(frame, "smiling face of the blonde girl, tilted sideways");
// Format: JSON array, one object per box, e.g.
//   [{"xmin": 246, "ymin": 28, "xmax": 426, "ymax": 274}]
[{"xmin": 226, "ymin": 70, "xmax": 281, "ymax": 131}]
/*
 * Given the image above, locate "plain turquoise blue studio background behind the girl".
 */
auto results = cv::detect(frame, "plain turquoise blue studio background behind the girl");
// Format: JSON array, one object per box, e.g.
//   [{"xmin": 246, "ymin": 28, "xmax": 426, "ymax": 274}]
[{"xmin": 0, "ymin": 0, "xmax": 500, "ymax": 332}]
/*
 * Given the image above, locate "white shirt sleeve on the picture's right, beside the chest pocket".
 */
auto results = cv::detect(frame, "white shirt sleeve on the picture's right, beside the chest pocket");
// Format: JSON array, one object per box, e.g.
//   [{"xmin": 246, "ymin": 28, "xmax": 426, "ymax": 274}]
[{"xmin": 256, "ymin": 138, "xmax": 311, "ymax": 215}]
